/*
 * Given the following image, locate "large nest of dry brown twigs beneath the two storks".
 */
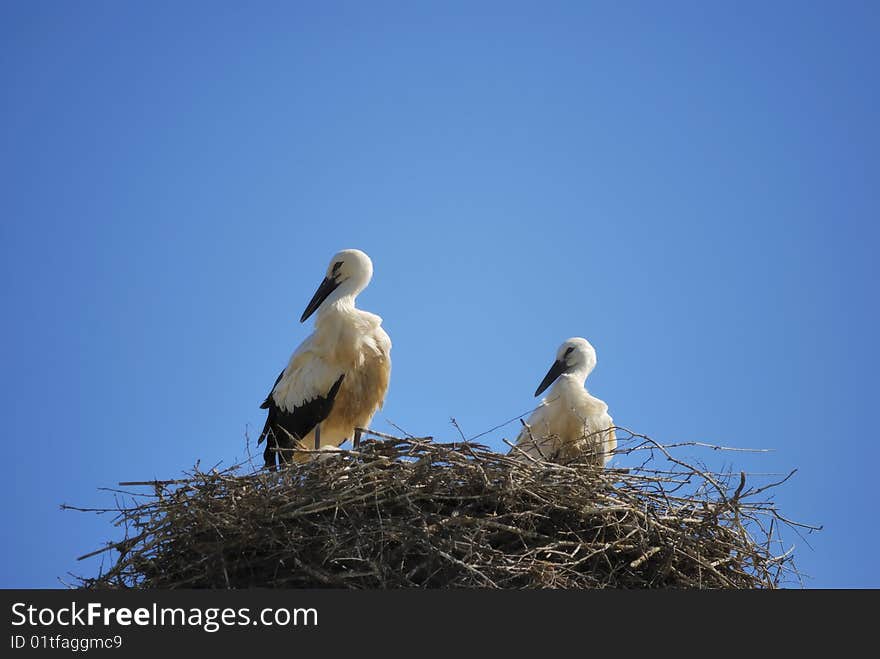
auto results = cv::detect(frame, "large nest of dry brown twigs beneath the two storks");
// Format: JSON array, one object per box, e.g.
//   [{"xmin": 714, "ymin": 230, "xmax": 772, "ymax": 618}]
[{"xmin": 72, "ymin": 435, "xmax": 797, "ymax": 588}]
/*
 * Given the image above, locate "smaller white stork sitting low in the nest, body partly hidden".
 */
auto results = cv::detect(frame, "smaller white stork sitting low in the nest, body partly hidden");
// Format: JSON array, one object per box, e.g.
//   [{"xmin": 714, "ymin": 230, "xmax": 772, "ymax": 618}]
[{"xmin": 511, "ymin": 337, "xmax": 617, "ymax": 467}]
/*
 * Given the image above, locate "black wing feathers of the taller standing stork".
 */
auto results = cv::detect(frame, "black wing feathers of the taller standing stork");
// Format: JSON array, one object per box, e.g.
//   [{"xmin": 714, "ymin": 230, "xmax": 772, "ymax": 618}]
[{"xmin": 257, "ymin": 371, "xmax": 345, "ymax": 468}]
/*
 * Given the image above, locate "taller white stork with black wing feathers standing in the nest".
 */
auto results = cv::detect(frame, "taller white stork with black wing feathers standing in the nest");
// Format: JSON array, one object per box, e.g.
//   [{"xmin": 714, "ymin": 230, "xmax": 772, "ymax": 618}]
[{"xmin": 257, "ymin": 249, "xmax": 391, "ymax": 467}]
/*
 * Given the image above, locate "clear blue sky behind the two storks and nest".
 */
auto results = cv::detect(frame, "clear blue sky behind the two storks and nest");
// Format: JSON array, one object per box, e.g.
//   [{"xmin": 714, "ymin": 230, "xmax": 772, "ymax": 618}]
[{"xmin": 0, "ymin": 0, "xmax": 880, "ymax": 587}]
